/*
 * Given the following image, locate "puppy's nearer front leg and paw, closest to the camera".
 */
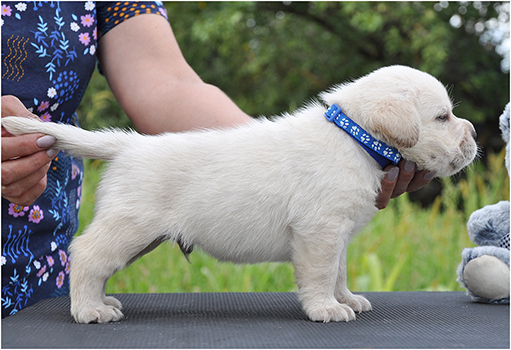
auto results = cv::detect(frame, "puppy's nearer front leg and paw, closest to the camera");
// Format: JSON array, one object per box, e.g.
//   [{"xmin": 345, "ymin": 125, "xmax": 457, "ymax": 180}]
[{"xmin": 293, "ymin": 222, "xmax": 355, "ymax": 322}]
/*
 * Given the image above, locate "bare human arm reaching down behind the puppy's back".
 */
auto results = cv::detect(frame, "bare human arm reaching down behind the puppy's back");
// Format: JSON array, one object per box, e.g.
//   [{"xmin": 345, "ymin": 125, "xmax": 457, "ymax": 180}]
[{"xmin": 98, "ymin": 15, "xmax": 250, "ymax": 134}]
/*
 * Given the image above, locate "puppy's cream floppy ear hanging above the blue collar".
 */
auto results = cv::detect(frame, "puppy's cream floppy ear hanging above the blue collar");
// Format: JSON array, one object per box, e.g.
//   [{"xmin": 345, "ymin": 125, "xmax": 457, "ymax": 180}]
[{"xmin": 365, "ymin": 91, "xmax": 421, "ymax": 149}]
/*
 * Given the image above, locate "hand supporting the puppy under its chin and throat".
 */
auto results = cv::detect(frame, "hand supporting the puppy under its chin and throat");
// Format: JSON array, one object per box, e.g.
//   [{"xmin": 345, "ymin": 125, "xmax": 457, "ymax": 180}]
[{"xmin": 376, "ymin": 159, "xmax": 435, "ymax": 209}]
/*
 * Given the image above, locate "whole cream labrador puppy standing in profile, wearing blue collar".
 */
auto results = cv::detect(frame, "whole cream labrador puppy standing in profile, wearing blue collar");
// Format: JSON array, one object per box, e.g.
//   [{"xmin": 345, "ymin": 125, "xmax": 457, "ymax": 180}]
[{"xmin": 2, "ymin": 66, "xmax": 477, "ymax": 323}]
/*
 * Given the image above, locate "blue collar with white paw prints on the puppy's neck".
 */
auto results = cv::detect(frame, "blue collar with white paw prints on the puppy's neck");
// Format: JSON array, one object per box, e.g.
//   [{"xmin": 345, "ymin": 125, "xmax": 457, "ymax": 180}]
[{"xmin": 325, "ymin": 103, "xmax": 401, "ymax": 168}]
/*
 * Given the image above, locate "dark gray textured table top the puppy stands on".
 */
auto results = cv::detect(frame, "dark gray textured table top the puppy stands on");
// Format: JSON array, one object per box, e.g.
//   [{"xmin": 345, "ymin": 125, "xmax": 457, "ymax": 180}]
[{"xmin": 2, "ymin": 292, "xmax": 510, "ymax": 349}]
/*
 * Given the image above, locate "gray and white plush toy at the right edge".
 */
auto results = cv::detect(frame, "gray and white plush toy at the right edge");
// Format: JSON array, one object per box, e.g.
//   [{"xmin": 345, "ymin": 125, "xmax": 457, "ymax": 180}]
[{"xmin": 457, "ymin": 104, "xmax": 510, "ymax": 304}]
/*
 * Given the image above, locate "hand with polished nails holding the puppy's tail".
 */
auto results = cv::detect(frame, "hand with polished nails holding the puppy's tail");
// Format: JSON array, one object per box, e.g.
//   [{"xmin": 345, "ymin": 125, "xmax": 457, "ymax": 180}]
[{"xmin": 1, "ymin": 96, "xmax": 58, "ymax": 206}]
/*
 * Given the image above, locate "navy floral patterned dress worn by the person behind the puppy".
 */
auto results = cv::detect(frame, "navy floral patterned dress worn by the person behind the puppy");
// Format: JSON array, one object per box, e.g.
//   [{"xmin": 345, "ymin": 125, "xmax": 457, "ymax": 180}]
[{"xmin": 0, "ymin": 1, "xmax": 167, "ymax": 318}]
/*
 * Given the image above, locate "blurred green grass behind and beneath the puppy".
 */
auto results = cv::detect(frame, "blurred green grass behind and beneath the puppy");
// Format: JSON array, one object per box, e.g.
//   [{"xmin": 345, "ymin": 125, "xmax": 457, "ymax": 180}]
[{"xmin": 78, "ymin": 150, "xmax": 509, "ymax": 293}]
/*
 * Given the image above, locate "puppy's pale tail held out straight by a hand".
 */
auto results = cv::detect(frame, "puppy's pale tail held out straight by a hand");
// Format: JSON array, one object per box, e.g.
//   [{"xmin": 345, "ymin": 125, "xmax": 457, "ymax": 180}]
[{"xmin": 1, "ymin": 117, "xmax": 138, "ymax": 160}]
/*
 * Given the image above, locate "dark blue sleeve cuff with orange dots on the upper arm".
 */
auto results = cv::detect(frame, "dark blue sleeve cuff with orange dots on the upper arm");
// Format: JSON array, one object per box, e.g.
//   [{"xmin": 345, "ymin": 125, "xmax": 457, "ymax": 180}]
[{"xmin": 96, "ymin": 1, "xmax": 168, "ymax": 39}]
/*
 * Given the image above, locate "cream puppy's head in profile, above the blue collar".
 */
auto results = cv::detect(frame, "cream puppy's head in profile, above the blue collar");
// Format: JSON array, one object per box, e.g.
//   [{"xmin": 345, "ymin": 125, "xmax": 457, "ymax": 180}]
[{"xmin": 321, "ymin": 66, "xmax": 477, "ymax": 176}]
